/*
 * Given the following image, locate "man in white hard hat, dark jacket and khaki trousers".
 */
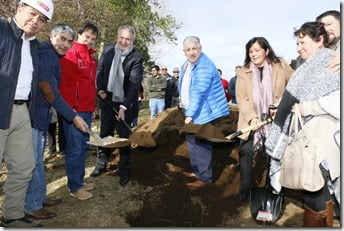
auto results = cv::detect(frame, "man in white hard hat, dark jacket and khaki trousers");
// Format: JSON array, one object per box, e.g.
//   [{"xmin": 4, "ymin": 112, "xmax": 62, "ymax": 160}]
[{"xmin": 0, "ymin": 0, "xmax": 54, "ymax": 228}]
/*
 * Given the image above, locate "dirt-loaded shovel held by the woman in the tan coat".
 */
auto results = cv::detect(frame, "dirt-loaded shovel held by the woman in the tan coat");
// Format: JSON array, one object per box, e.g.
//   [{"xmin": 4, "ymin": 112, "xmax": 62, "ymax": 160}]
[{"xmin": 196, "ymin": 117, "xmax": 272, "ymax": 143}]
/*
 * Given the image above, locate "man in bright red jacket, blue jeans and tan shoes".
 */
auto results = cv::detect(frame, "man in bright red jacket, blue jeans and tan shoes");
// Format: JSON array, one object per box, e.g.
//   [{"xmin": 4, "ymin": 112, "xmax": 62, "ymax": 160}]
[{"xmin": 59, "ymin": 23, "xmax": 98, "ymax": 200}]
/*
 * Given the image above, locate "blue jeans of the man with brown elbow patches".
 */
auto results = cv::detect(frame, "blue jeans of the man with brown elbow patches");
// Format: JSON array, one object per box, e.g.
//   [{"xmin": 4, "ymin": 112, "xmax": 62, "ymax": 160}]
[{"xmin": 24, "ymin": 128, "xmax": 47, "ymax": 212}]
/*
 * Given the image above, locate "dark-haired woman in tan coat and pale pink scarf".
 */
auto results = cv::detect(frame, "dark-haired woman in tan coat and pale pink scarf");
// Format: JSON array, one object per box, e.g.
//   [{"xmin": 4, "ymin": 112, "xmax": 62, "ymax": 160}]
[{"xmin": 236, "ymin": 37, "xmax": 293, "ymax": 201}]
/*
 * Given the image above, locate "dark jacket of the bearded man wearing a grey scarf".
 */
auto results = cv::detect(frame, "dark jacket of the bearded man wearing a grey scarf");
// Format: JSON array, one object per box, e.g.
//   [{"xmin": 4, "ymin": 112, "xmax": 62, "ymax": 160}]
[{"xmin": 97, "ymin": 45, "xmax": 143, "ymax": 118}]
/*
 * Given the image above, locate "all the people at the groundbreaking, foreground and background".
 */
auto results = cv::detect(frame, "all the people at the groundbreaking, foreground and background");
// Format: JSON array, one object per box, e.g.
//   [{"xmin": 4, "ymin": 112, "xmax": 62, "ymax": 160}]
[{"xmin": 0, "ymin": 0, "xmax": 340, "ymax": 227}]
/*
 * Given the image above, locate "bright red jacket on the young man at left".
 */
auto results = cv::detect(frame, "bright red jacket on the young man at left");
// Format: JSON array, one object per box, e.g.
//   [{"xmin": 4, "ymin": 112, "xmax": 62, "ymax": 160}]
[{"xmin": 59, "ymin": 42, "xmax": 97, "ymax": 112}]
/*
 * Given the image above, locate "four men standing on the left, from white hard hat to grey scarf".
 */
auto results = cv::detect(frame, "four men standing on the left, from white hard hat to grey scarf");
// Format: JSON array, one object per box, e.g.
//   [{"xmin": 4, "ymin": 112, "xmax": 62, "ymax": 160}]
[{"xmin": 0, "ymin": 0, "xmax": 143, "ymax": 228}]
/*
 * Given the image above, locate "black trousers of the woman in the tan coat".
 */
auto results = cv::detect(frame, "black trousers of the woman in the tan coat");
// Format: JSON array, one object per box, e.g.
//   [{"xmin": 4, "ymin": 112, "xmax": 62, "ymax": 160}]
[{"xmin": 239, "ymin": 135, "xmax": 254, "ymax": 197}]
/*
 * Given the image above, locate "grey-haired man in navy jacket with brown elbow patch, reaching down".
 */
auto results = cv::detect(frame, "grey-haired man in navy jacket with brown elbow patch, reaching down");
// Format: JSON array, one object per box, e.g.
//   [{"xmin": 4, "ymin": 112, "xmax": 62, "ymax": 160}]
[{"xmin": 25, "ymin": 24, "xmax": 87, "ymax": 219}]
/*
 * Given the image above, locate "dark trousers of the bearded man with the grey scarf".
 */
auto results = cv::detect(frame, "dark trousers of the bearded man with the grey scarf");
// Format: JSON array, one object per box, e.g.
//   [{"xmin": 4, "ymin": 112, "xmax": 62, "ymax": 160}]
[{"xmin": 97, "ymin": 103, "xmax": 132, "ymax": 178}]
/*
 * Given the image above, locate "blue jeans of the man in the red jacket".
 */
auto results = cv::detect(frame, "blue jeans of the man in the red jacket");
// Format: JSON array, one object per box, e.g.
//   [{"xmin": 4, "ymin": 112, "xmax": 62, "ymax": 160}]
[{"xmin": 63, "ymin": 112, "xmax": 92, "ymax": 192}]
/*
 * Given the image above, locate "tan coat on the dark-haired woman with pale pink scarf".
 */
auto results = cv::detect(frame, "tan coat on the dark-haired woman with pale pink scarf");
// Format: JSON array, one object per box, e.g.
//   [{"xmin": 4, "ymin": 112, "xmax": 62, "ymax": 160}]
[{"xmin": 235, "ymin": 59, "xmax": 294, "ymax": 140}]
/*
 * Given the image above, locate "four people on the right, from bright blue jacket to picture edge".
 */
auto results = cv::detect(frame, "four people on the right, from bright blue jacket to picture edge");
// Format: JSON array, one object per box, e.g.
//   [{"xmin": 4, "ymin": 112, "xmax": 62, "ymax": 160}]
[{"xmin": 179, "ymin": 11, "xmax": 340, "ymax": 227}]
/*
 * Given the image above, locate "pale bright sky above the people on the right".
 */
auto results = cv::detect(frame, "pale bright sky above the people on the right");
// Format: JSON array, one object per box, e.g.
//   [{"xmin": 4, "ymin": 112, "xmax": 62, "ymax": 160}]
[{"xmin": 151, "ymin": 0, "xmax": 340, "ymax": 78}]
